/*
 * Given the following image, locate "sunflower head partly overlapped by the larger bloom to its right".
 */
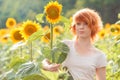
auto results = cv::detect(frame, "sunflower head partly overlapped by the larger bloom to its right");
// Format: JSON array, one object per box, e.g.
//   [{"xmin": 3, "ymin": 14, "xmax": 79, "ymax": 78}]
[{"xmin": 10, "ymin": 28, "xmax": 23, "ymax": 43}]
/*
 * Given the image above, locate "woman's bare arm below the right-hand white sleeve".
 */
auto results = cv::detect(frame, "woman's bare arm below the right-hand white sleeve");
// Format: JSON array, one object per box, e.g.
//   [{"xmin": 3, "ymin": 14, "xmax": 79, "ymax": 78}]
[{"xmin": 96, "ymin": 67, "xmax": 106, "ymax": 80}]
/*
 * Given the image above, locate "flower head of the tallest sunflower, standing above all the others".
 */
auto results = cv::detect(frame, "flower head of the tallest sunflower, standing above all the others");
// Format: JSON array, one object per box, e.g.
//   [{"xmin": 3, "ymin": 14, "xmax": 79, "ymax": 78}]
[{"xmin": 45, "ymin": 1, "xmax": 62, "ymax": 24}]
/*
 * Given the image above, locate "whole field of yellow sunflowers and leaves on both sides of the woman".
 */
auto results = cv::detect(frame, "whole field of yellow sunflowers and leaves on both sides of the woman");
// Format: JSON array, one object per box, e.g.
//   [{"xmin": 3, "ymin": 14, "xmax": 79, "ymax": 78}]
[{"xmin": 0, "ymin": 0, "xmax": 120, "ymax": 80}]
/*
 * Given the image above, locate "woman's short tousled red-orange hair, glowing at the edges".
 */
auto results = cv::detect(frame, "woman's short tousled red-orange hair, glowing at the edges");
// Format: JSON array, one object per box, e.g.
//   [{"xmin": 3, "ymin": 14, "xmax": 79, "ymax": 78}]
[{"xmin": 71, "ymin": 8, "xmax": 103, "ymax": 40}]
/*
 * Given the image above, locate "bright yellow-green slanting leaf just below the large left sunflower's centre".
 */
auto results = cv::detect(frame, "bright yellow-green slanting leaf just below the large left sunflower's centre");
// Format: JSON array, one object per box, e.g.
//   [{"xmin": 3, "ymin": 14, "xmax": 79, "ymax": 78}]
[{"xmin": 27, "ymin": 30, "xmax": 43, "ymax": 43}]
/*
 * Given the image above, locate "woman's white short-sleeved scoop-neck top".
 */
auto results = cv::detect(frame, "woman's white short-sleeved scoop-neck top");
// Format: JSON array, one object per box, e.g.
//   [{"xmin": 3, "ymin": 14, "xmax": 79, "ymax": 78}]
[{"xmin": 62, "ymin": 40, "xmax": 107, "ymax": 80}]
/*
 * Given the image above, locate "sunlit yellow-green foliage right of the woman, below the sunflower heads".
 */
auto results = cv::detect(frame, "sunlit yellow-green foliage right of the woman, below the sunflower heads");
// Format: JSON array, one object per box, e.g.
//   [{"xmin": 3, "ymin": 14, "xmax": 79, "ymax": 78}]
[{"xmin": 95, "ymin": 35, "xmax": 120, "ymax": 80}]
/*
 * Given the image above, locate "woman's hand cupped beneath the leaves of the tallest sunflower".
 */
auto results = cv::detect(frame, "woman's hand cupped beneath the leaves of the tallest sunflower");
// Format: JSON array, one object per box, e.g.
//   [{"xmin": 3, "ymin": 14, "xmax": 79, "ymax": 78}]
[{"xmin": 42, "ymin": 59, "xmax": 60, "ymax": 72}]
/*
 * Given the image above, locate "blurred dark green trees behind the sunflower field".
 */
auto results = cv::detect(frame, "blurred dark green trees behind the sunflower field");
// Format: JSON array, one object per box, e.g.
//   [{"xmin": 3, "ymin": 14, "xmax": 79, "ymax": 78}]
[{"xmin": 0, "ymin": 0, "xmax": 120, "ymax": 28}]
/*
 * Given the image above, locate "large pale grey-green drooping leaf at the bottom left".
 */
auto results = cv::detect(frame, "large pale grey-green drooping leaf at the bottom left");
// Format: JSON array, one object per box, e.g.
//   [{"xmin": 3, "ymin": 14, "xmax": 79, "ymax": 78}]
[{"xmin": 16, "ymin": 62, "xmax": 41, "ymax": 79}]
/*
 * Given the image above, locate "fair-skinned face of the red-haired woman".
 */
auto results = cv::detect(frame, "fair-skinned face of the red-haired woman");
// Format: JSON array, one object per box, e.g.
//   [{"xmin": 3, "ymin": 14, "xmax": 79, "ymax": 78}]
[{"xmin": 75, "ymin": 22, "xmax": 91, "ymax": 38}]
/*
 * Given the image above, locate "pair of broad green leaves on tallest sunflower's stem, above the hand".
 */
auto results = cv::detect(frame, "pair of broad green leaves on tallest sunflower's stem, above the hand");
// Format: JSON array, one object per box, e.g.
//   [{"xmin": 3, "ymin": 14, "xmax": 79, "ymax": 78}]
[{"xmin": 42, "ymin": 42, "xmax": 69, "ymax": 63}]
